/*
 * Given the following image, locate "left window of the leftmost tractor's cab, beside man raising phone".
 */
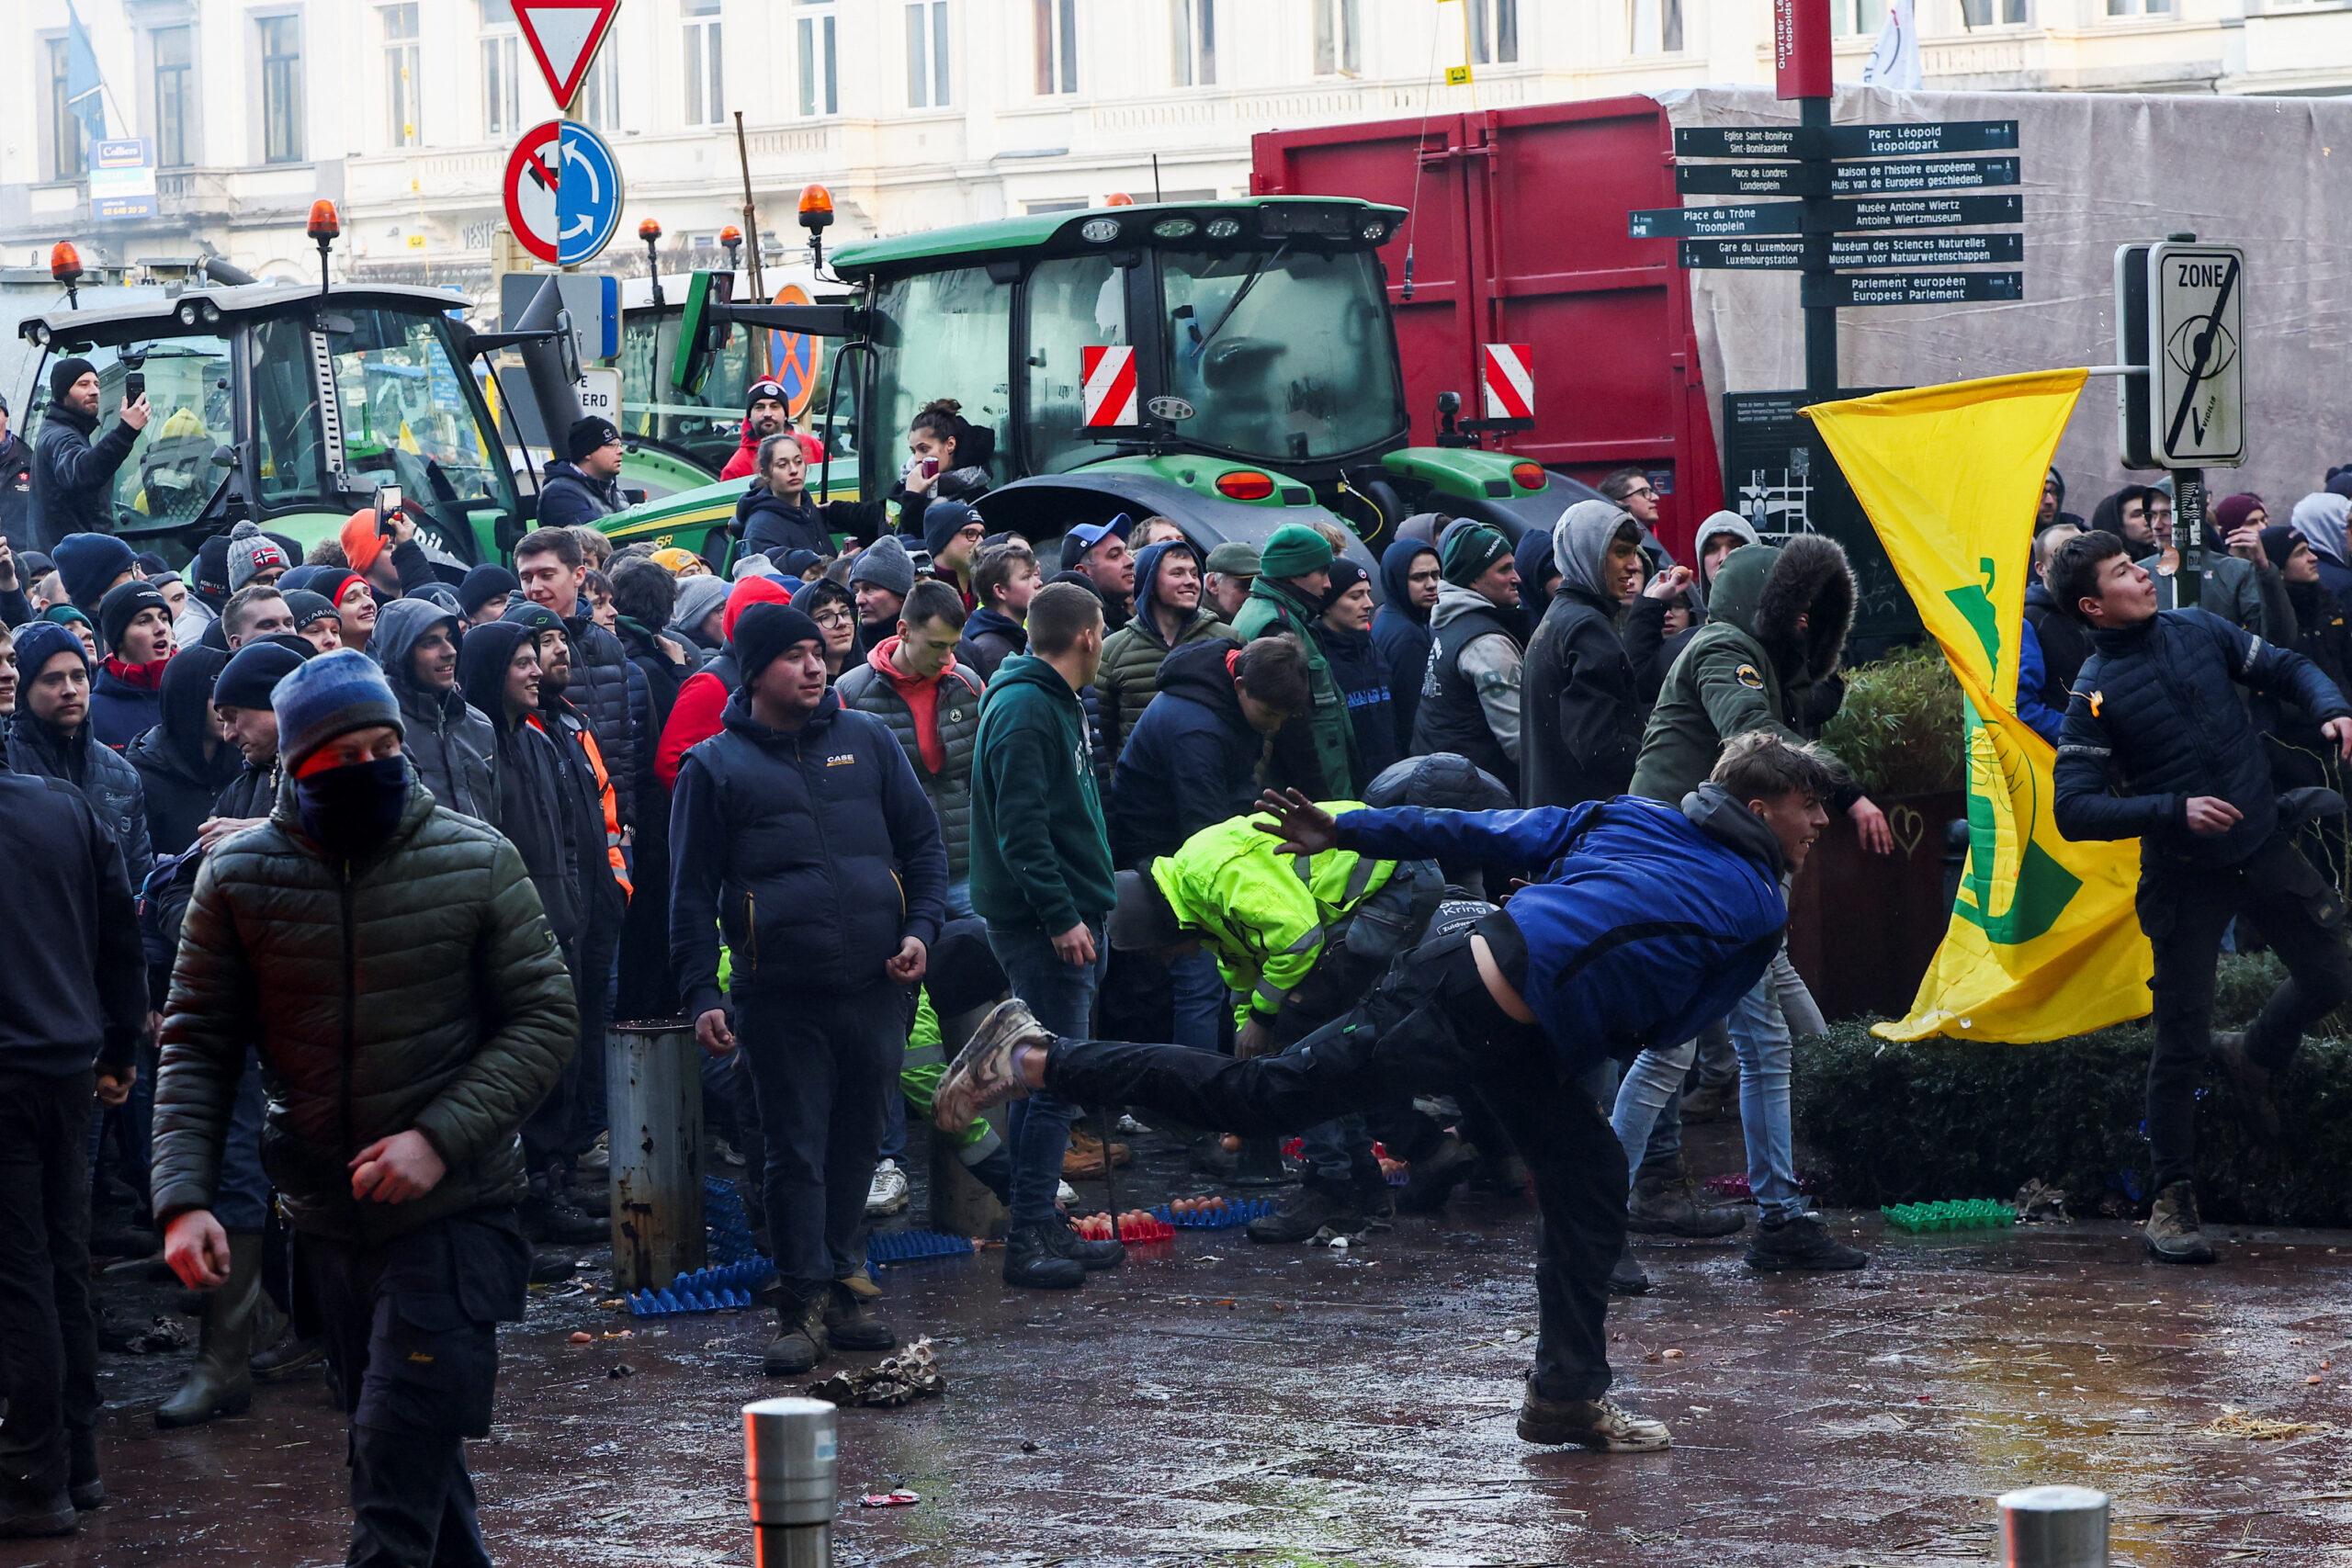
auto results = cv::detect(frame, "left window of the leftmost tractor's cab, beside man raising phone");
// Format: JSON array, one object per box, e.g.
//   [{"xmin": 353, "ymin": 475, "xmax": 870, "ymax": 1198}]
[{"xmin": 38, "ymin": 336, "xmax": 235, "ymax": 529}]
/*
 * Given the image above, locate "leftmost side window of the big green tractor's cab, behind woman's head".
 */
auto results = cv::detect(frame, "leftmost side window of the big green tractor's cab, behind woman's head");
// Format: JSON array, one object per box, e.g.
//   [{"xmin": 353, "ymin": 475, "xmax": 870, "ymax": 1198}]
[{"xmin": 873, "ymin": 268, "xmax": 1013, "ymax": 489}]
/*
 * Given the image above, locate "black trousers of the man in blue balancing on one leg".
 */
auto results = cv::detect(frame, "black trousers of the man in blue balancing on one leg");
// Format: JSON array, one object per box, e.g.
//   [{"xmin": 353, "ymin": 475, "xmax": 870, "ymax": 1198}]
[{"xmin": 1045, "ymin": 931, "xmax": 1625, "ymax": 1399}]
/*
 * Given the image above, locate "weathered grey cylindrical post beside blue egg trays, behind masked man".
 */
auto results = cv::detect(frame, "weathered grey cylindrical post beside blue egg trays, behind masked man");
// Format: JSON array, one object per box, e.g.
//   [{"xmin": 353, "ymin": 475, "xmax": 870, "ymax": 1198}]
[{"xmin": 605, "ymin": 1021, "xmax": 708, "ymax": 1295}]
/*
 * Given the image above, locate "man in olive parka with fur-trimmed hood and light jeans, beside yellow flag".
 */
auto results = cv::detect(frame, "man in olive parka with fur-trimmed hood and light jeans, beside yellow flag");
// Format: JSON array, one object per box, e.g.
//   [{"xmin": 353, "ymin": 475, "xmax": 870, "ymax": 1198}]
[{"xmin": 1611, "ymin": 534, "xmax": 1894, "ymax": 1291}]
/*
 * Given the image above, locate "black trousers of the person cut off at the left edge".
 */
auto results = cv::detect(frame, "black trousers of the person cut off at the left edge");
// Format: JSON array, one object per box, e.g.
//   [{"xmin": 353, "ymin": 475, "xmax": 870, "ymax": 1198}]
[{"xmin": 0, "ymin": 1069, "xmax": 99, "ymax": 1505}]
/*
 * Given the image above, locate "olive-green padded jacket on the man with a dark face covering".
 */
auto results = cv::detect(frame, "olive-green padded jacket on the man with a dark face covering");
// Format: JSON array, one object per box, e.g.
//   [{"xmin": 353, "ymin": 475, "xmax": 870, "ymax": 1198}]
[{"xmin": 153, "ymin": 769, "xmax": 579, "ymax": 1246}]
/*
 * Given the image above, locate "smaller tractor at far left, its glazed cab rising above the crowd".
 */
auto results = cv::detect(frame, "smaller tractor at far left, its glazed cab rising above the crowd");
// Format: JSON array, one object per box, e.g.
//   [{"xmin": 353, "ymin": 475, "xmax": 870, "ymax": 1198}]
[{"xmin": 5, "ymin": 282, "xmax": 724, "ymax": 576}]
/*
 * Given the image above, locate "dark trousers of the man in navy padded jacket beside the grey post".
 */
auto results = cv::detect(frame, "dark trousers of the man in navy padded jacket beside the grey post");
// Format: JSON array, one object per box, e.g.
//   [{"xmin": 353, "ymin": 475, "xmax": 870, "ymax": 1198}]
[{"xmin": 734, "ymin": 985, "xmax": 906, "ymax": 1286}]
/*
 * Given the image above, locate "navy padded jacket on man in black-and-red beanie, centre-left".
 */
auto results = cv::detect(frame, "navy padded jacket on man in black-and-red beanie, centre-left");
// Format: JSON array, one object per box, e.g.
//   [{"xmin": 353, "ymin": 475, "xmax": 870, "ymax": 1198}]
[{"xmin": 671, "ymin": 691, "xmax": 948, "ymax": 1018}]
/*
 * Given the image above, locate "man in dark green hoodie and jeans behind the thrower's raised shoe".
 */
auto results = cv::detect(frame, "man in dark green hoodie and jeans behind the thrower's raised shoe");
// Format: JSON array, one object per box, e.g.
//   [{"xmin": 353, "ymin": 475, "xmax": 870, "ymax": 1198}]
[{"xmin": 971, "ymin": 583, "xmax": 1125, "ymax": 1291}]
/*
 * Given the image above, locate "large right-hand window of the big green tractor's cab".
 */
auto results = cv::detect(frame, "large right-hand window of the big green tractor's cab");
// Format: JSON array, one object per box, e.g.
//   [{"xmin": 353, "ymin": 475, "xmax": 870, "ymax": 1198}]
[{"xmin": 1159, "ymin": 249, "xmax": 1404, "ymax": 463}]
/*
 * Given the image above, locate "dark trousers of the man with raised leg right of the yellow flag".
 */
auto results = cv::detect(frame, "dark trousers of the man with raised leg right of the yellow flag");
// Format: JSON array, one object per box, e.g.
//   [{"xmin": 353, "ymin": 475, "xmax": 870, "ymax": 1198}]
[{"xmin": 2135, "ymin": 832, "xmax": 2352, "ymax": 1190}]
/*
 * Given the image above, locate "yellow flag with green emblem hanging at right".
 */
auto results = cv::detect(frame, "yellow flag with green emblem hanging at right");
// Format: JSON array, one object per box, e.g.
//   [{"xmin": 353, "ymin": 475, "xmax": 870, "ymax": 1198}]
[{"xmin": 1806, "ymin": 369, "xmax": 2152, "ymax": 1043}]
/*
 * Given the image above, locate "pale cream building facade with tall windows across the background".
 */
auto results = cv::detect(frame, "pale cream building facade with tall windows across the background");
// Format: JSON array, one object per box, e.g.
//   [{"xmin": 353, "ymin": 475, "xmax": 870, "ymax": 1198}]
[{"xmin": 0, "ymin": 0, "xmax": 2352, "ymax": 294}]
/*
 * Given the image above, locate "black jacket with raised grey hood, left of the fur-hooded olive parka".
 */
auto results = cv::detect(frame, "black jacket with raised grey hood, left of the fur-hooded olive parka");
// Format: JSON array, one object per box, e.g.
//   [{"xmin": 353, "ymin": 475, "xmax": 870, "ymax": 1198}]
[{"xmin": 1520, "ymin": 501, "xmax": 1656, "ymax": 807}]
